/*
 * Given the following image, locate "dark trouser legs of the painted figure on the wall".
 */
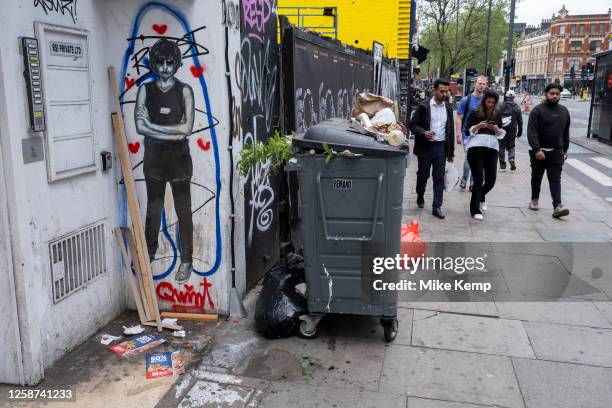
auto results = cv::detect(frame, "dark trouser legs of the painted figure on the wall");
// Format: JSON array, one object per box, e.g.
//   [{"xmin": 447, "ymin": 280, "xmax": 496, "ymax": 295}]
[{"xmin": 145, "ymin": 177, "xmax": 193, "ymax": 263}]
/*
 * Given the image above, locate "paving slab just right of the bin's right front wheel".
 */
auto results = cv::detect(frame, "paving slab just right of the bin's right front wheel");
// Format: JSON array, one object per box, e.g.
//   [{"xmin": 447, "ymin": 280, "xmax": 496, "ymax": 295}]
[{"xmin": 412, "ymin": 310, "xmax": 535, "ymax": 358}]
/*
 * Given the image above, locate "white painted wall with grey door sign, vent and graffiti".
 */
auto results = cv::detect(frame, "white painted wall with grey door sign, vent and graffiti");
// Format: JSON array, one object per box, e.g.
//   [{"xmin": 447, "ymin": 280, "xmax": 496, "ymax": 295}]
[{"xmin": 0, "ymin": 0, "xmax": 245, "ymax": 384}]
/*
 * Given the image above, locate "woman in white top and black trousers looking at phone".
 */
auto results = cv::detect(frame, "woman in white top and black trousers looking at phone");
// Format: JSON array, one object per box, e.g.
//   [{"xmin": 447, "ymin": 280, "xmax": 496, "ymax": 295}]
[{"xmin": 466, "ymin": 91, "xmax": 506, "ymax": 220}]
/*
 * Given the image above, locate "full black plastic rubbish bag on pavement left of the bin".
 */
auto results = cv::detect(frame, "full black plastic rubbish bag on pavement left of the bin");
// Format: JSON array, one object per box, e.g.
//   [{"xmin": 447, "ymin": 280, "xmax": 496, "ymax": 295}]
[{"xmin": 255, "ymin": 253, "xmax": 306, "ymax": 338}]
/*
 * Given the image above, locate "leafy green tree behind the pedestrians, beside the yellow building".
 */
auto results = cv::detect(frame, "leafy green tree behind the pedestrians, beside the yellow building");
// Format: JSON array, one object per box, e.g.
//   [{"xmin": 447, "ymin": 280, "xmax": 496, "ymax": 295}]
[{"xmin": 419, "ymin": 0, "xmax": 520, "ymax": 76}]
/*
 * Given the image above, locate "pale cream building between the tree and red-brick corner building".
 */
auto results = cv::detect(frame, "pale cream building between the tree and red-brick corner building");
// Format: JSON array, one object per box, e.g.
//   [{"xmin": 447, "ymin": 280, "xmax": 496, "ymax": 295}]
[{"xmin": 515, "ymin": 29, "xmax": 550, "ymax": 93}]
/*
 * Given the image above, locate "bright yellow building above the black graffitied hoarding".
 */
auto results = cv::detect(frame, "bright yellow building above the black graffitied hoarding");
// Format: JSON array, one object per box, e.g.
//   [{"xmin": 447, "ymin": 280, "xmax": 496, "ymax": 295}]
[{"xmin": 278, "ymin": 0, "xmax": 410, "ymax": 59}]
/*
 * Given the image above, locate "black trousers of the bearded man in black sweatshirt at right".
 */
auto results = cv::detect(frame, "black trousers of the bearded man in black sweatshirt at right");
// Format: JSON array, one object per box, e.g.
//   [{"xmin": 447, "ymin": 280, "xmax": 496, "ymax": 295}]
[{"xmin": 529, "ymin": 149, "xmax": 564, "ymax": 208}]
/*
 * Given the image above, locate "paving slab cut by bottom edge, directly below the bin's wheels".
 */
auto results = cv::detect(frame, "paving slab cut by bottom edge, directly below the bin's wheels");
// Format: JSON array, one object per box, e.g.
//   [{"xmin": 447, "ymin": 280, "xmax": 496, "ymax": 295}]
[{"xmin": 259, "ymin": 383, "xmax": 406, "ymax": 408}]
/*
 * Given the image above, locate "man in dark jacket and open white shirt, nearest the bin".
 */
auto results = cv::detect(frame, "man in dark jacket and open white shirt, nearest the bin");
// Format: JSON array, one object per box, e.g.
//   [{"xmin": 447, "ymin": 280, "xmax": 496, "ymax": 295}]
[{"xmin": 408, "ymin": 79, "xmax": 455, "ymax": 219}]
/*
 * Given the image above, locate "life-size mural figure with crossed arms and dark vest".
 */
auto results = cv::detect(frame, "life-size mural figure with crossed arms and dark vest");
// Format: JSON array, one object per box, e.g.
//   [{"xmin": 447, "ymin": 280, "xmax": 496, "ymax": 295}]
[{"xmin": 134, "ymin": 39, "xmax": 194, "ymax": 283}]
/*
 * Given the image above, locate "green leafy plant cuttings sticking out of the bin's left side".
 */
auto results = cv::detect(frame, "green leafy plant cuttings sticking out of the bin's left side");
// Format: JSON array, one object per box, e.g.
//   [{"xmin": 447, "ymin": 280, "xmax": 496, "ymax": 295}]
[{"xmin": 236, "ymin": 131, "xmax": 293, "ymax": 176}]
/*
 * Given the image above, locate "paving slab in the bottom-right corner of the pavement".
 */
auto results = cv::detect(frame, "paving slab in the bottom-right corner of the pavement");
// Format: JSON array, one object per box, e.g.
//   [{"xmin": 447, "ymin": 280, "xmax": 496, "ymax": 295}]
[{"xmin": 512, "ymin": 358, "xmax": 612, "ymax": 408}]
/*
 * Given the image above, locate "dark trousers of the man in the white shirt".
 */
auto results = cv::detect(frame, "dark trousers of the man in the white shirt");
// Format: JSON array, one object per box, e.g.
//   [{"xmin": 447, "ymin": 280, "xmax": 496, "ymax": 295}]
[{"xmin": 416, "ymin": 142, "xmax": 446, "ymax": 208}]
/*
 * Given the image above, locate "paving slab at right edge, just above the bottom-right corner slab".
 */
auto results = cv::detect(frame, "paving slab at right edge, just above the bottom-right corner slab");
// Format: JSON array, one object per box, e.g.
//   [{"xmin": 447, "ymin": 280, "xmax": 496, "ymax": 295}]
[{"xmin": 525, "ymin": 322, "xmax": 612, "ymax": 367}]
